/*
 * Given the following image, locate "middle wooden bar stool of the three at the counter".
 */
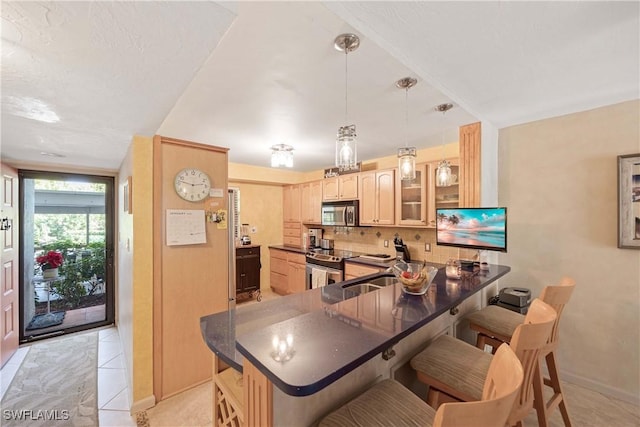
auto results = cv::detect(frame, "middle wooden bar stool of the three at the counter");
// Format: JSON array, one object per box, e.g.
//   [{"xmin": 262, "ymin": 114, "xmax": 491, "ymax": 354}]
[{"xmin": 411, "ymin": 299, "xmax": 557, "ymax": 426}]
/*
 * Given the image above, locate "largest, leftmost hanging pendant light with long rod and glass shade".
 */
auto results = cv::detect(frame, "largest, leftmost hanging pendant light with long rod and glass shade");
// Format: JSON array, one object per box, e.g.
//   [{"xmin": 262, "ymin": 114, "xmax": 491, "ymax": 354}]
[{"xmin": 334, "ymin": 34, "xmax": 360, "ymax": 168}]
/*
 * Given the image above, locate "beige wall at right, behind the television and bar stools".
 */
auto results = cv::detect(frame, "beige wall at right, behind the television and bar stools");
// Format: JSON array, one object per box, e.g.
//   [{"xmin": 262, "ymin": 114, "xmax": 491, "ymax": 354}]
[{"xmin": 499, "ymin": 101, "xmax": 640, "ymax": 404}]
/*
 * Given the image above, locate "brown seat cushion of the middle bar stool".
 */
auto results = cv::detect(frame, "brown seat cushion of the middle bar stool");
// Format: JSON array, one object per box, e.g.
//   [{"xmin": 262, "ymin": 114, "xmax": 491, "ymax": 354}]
[{"xmin": 411, "ymin": 335, "xmax": 492, "ymax": 401}]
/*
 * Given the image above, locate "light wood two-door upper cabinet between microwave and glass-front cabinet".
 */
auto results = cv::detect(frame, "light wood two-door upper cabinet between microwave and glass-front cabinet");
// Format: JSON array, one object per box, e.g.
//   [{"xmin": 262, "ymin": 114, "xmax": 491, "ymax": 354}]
[{"xmin": 359, "ymin": 169, "xmax": 396, "ymax": 225}]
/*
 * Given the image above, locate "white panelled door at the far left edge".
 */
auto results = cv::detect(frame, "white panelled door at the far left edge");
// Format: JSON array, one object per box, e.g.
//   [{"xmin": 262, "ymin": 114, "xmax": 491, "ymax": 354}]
[{"xmin": 0, "ymin": 164, "xmax": 19, "ymax": 367}]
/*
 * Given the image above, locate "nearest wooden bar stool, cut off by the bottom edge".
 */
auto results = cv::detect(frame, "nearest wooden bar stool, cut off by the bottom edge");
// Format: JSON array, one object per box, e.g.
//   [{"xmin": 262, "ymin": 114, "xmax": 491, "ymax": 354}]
[{"xmin": 319, "ymin": 344, "xmax": 524, "ymax": 427}]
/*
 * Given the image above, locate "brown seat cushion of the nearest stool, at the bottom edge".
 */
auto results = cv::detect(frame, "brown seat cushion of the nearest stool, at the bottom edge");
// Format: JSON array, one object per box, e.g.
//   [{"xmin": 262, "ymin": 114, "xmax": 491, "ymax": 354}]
[{"xmin": 319, "ymin": 379, "xmax": 436, "ymax": 427}]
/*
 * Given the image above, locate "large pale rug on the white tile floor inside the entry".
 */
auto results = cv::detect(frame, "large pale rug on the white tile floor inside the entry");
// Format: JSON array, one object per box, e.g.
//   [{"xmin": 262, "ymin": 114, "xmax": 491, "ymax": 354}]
[{"xmin": 0, "ymin": 332, "xmax": 98, "ymax": 427}]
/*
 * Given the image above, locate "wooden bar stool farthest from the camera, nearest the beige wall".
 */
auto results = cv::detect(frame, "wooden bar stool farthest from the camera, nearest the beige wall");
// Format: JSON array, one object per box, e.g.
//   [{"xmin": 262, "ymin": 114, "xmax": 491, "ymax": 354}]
[{"xmin": 467, "ymin": 277, "xmax": 576, "ymax": 427}]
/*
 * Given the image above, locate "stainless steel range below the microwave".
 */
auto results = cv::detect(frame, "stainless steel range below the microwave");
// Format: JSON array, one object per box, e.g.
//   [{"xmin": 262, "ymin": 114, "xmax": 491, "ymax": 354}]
[{"xmin": 306, "ymin": 249, "xmax": 359, "ymax": 289}]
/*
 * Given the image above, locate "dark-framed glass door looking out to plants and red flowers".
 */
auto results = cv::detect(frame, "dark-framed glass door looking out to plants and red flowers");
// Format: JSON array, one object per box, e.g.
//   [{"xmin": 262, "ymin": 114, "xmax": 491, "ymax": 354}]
[{"xmin": 18, "ymin": 170, "xmax": 115, "ymax": 342}]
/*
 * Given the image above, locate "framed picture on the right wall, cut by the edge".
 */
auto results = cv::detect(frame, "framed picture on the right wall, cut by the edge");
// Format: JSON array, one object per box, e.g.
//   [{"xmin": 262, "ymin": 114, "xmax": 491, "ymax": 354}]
[{"xmin": 618, "ymin": 153, "xmax": 640, "ymax": 249}]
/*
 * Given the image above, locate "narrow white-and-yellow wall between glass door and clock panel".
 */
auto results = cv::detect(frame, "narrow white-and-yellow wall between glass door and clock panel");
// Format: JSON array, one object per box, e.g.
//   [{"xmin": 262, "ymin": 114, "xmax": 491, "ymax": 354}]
[{"xmin": 116, "ymin": 136, "xmax": 155, "ymax": 412}]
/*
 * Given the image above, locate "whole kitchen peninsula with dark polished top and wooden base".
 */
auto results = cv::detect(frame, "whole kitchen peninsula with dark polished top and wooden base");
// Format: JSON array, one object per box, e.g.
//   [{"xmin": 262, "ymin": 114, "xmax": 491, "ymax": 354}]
[{"xmin": 200, "ymin": 265, "xmax": 510, "ymax": 426}]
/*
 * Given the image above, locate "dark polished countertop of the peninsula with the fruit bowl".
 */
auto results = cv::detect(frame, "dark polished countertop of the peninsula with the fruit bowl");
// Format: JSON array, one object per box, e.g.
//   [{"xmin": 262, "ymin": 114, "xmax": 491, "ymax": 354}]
[{"xmin": 200, "ymin": 265, "xmax": 510, "ymax": 396}]
